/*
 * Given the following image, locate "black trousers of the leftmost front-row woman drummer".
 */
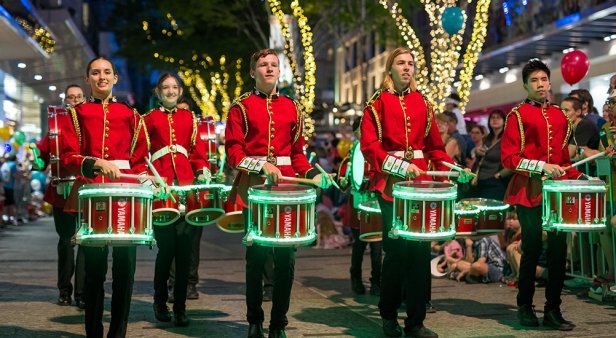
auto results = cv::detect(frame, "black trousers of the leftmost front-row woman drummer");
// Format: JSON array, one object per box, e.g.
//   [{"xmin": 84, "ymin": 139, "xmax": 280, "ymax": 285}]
[{"xmin": 83, "ymin": 246, "xmax": 137, "ymax": 338}]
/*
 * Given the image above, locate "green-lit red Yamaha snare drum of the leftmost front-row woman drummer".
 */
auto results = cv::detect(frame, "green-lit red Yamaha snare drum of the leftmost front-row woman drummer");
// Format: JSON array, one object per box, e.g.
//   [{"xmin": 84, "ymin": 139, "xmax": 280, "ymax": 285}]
[{"xmin": 75, "ymin": 183, "xmax": 155, "ymax": 246}]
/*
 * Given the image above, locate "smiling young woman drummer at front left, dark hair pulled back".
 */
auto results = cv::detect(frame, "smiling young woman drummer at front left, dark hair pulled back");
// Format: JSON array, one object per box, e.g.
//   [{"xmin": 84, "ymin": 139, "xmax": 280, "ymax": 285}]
[{"xmin": 61, "ymin": 57, "xmax": 148, "ymax": 337}]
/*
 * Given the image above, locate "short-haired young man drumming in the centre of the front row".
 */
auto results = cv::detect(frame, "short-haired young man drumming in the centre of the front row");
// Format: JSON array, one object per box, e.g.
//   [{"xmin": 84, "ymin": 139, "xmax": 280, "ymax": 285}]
[{"xmin": 225, "ymin": 49, "xmax": 331, "ymax": 337}]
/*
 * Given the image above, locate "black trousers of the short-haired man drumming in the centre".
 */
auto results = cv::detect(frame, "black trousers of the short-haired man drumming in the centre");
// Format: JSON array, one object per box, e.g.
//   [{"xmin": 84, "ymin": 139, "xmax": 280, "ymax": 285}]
[{"xmin": 242, "ymin": 209, "xmax": 295, "ymax": 330}]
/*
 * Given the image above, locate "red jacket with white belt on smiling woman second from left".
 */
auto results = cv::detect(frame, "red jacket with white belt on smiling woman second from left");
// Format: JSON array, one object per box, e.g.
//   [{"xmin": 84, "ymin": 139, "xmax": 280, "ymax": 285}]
[{"xmin": 143, "ymin": 107, "xmax": 209, "ymax": 185}]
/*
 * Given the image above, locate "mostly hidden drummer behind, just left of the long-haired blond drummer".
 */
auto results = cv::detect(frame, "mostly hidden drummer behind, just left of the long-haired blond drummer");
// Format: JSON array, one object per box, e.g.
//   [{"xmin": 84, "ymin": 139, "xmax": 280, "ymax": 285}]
[{"xmin": 338, "ymin": 119, "xmax": 383, "ymax": 296}]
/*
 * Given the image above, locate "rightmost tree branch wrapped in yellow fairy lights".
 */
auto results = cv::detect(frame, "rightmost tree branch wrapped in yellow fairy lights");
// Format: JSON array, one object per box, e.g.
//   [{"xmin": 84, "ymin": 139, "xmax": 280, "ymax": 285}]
[{"xmin": 457, "ymin": 0, "xmax": 491, "ymax": 113}]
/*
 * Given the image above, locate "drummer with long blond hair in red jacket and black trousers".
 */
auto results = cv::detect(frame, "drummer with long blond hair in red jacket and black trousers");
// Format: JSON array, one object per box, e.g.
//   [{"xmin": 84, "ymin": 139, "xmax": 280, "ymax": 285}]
[{"xmin": 360, "ymin": 47, "xmax": 470, "ymax": 337}]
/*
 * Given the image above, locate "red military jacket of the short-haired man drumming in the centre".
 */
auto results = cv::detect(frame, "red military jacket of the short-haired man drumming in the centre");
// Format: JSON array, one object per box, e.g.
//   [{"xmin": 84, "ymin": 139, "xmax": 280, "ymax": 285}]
[{"xmin": 225, "ymin": 89, "xmax": 318, "ymax": 207}]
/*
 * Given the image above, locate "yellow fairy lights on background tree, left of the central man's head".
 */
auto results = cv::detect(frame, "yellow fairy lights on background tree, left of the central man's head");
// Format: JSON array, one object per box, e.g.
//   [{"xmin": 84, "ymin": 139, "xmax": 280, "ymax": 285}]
[{"xmin": 142, "ymin": 13, "xmax": 244, "ymax": 121}]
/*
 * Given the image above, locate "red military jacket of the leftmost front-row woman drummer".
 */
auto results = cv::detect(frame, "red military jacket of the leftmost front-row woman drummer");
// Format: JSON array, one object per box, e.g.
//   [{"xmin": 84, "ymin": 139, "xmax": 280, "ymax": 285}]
[{"xmin": 61, "ymin": 97, "xmax": 148, "ymax": 211}]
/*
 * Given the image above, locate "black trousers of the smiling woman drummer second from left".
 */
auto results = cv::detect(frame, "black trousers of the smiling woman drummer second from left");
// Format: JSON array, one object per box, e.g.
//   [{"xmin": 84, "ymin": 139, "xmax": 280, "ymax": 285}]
[{"xmin": 154, "ymin": 217, "xmax": 195, "ymax": 313}]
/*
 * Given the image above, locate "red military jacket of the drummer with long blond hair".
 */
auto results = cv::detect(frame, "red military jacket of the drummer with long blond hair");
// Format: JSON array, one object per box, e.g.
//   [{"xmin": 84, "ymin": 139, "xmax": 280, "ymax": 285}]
[{"xmin": 360, "ymin": 89, "xmax": 454, "ymax": 200}]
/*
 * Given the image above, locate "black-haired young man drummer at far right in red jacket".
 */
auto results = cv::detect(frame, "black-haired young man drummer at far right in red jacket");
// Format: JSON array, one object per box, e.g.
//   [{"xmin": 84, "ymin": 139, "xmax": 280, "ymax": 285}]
[{"xmin": 501, "ymin": 59, "xmax": 586, "ymax": 331}]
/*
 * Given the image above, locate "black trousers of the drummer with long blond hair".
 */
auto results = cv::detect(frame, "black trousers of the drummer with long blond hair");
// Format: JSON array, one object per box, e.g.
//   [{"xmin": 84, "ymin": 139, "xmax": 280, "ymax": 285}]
[{"xmin": 379, "ymin": 196, "xmax": 430, "ymax": 329}]
